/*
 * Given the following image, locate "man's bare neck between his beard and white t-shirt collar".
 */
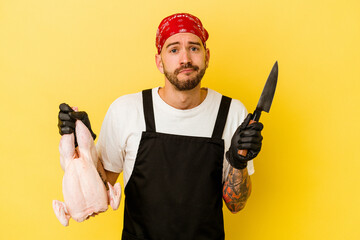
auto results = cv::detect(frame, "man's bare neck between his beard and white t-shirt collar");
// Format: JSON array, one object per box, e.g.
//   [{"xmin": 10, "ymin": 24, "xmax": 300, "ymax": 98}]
[{"xmin": 159, "ymin": 83, "xmax": 207, "ymax": 110}]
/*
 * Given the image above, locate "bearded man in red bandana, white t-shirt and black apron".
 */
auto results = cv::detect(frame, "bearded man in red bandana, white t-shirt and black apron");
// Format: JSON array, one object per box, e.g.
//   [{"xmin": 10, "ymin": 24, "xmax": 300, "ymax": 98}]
[{"xmin": 59, "ymin": 13, "xmax": 263, "ymax": 240}]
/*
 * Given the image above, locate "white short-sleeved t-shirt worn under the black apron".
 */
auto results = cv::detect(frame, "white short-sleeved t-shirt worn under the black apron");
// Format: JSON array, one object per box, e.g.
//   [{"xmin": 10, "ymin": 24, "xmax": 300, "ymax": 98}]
[{"xmin": 96, "ymin": 87, "xmax": 254, "ymax": 186}]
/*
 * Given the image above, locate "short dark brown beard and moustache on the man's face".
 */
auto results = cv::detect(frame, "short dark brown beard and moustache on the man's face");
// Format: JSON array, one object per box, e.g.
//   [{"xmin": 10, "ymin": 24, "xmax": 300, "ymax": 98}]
[{"xmin": 164, "ymin": 63, "xmax": 206, "ymax": 91}]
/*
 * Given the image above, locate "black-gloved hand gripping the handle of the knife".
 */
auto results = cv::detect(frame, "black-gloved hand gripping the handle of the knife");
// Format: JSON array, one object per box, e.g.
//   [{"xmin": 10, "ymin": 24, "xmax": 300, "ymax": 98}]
[{"xmin": 226, "ymin": 113, "xmax": 264, "ymax": 169}]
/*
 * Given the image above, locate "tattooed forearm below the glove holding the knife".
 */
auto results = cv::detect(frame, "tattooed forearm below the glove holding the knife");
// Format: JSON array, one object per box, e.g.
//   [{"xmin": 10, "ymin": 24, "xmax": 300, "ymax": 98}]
[{"xmin": 223, "ymin": 166, "xmax": 251, "ymax": 213}]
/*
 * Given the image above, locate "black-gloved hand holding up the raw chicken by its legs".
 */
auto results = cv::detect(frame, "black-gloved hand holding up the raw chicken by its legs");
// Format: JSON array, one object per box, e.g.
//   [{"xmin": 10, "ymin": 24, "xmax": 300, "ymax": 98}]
[{"xmin": 58, "ymin": 103, "xmax": 96, "ymax": 143}]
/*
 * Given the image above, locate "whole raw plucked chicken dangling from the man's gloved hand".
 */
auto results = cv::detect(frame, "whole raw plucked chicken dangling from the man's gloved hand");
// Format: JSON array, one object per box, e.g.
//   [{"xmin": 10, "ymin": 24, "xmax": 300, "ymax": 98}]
[{"xmin": 53, "ymin": 120, "xmax": 121, "ymax": 226}]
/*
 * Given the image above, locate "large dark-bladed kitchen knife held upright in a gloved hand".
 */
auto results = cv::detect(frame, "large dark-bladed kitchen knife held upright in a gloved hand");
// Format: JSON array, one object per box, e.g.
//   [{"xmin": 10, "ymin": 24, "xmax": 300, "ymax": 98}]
[{"xmin": 238, "ymin": 61, "xmax": 279, "ymax": 157}]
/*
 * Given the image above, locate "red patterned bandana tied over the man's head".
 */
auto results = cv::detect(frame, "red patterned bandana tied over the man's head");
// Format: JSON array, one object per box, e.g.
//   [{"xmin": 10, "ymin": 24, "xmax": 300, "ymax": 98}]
[{"xmin": 156, "ymin": 13, "xmax": 209, "ymax": 54}]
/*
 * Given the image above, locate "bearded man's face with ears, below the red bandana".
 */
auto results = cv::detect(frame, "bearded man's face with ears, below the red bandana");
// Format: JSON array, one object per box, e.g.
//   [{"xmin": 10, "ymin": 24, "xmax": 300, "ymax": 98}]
[{"xmin": 156, "ymin": 33, "xmax": 210, "ymax": 91}]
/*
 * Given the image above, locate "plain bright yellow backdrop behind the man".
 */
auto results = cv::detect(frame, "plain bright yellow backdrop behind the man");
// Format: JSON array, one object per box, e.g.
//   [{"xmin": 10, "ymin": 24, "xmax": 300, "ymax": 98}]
[{"xmin": 0, "ymin": 0, "xmax": 360, "ymax": 240}]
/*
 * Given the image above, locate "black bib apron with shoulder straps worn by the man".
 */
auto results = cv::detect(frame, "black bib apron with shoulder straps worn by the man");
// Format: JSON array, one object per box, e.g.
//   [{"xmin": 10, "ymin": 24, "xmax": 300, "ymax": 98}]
[{"xmin": 122, "ymin": 89, "xmax": 231, "ymax": 240}]
